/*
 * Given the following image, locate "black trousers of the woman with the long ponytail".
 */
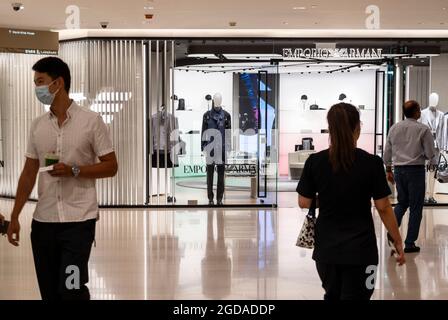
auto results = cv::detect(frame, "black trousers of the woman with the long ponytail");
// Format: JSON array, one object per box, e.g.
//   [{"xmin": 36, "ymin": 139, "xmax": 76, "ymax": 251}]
[{"xmin": 316, "ymin": 262, "xmax": 375, "ymax": 300}]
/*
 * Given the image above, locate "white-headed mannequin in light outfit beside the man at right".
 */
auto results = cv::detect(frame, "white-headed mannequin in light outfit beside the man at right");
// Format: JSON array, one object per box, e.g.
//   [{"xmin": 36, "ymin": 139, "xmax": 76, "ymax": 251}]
[{"xmin": 420, "ymin": 92, "xmax": 444, "ymax": 203}]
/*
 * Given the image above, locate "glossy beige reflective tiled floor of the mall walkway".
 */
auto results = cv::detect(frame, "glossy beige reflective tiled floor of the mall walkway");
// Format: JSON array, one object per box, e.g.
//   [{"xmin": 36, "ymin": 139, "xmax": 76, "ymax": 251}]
[{"xmin": 0, "ymin": 201, "xmax": 448, "ymax": 299}]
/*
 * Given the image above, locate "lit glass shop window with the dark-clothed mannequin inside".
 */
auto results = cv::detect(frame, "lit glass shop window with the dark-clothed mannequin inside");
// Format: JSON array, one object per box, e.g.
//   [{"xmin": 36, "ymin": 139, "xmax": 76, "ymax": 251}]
[{"xmin": 173, "ymin": 63, "xmax": 278, "ymax": 206}]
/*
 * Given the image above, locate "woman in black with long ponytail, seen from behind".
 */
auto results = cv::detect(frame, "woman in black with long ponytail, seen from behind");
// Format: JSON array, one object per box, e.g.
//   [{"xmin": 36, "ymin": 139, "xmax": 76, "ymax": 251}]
[{"xmin": 297, "ymin": 103, "xmax": 405, "ymax": 300}]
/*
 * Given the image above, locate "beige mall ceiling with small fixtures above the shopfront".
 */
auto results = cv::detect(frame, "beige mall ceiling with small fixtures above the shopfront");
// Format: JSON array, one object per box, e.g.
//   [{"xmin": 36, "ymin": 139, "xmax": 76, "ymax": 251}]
[{"xmin": 0, "ymin": 0, "xmax": 448, "ymax": 30}]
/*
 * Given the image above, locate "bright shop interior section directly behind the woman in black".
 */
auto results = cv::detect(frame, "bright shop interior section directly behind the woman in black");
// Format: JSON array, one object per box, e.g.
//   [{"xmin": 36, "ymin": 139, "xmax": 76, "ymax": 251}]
[{"xmin": 272, "ymin": 61, "xmax": 393, "ymax": 207}]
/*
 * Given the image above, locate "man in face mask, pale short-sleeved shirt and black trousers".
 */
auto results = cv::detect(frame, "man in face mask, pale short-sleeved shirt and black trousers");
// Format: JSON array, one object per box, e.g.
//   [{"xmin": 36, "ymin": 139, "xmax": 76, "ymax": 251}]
[{"xmin": 3, "ymin": 57, "xmax": 118, "ymax": 300}]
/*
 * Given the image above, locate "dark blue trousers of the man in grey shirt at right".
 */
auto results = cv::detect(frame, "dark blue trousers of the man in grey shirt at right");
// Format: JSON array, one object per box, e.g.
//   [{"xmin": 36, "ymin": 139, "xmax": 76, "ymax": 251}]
[{"xmin": 394, "ymin": 166, "xmax": 426, "ymax": 246}]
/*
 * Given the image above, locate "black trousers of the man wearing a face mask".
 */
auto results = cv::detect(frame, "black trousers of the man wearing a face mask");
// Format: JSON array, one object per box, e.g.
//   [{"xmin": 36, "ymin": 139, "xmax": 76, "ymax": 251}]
[{"xmin": 31, "ymin": 220, "xmax": 96, "ymax": 300}]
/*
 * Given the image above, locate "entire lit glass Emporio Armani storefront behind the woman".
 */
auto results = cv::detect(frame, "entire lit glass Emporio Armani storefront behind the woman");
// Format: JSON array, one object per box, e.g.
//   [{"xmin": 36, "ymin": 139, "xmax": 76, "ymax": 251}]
[{"xmin": 147, "ymin": 38, "xmax": 394, "ymax": 207}]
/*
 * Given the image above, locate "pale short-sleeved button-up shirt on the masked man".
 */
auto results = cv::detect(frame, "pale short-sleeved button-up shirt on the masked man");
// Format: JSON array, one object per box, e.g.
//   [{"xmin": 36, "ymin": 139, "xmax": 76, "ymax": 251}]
[{"xmin": 25, "ymin": 102, "xmax": 114, "ymax": 222}]
